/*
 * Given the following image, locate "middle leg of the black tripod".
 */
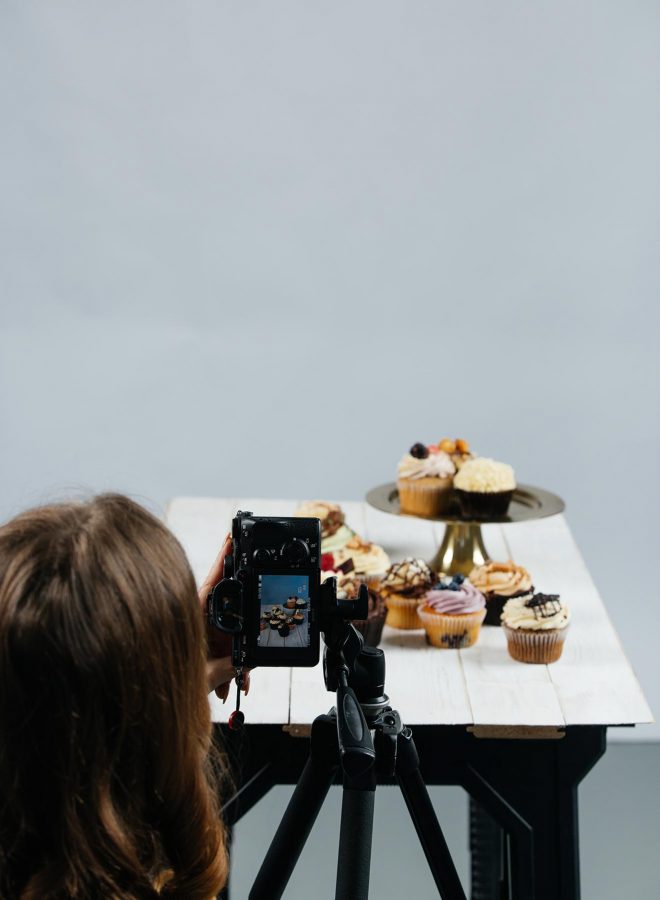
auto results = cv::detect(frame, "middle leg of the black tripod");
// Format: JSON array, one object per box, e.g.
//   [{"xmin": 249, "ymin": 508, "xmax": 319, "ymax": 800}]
[{"xmin": 335, "ymin": 774, "xmax": 376, "ymax": 900}]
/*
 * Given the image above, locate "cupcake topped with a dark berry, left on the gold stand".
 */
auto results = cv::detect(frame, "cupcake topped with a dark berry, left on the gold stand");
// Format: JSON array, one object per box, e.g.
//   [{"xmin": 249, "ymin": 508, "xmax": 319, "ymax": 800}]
[{"xmin": 396, "ymin": 444, "xmax": 456, "ymax": 519}]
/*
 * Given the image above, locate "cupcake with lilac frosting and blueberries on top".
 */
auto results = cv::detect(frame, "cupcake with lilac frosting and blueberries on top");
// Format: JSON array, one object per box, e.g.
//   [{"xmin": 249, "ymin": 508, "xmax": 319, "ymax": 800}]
[{"xmin": 417, "ymin": 575, "xmax": 486, "ymax": 650}]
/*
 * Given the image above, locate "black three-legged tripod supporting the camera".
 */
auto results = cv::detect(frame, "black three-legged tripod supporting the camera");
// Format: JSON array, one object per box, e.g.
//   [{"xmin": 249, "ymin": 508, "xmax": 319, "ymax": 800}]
[{"xmin": 250, "ymin": 618, "xmax": 465, "ymax": 900}]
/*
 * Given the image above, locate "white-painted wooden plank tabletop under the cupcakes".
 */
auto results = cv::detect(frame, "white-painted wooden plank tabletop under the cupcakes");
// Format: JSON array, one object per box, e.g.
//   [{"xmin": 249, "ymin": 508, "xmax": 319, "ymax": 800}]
[{"xmin": 167, "ymin": 498, "xmax": 652, "ymax": 727}]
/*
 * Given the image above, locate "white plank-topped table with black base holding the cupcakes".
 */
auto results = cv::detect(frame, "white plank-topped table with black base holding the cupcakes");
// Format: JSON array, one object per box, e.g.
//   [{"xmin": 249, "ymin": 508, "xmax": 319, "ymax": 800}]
[{"xmin": 167, "ymin": 498, "xmax": 652, "ymax": 900}]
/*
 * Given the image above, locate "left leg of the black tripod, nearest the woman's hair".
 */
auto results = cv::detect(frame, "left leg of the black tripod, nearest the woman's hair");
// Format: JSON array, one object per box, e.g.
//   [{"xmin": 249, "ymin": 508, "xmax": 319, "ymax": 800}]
[{"xmin": 250, "ymin": 716, "xmax": 339, "ymax": 900}]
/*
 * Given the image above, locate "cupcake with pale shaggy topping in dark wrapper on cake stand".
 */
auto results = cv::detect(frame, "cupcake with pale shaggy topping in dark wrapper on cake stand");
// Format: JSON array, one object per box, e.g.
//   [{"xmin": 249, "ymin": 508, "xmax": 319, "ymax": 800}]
[{"xmin": 454, "ymin": 456, "xmax": 516, "ymax": 519}]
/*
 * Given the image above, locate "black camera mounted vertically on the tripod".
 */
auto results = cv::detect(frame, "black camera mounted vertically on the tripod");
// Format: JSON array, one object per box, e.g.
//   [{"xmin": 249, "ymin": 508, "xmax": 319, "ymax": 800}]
[{"xmin": 208, "ymin": 511, "xmax": 368, "ymax": 668}]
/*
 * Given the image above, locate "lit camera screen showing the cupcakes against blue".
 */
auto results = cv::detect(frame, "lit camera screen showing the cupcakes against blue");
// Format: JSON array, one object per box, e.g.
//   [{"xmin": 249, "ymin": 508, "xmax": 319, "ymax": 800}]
[{"xmin": 259, "ymin": 575, "xmax": 311, "ymax": 650}]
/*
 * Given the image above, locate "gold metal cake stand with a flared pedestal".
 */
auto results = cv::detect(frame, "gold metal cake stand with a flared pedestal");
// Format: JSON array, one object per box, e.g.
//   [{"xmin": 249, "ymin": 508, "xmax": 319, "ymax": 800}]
[{"xmin": 366, "ymin": 482, "xmax": 565, "ymax": 575}]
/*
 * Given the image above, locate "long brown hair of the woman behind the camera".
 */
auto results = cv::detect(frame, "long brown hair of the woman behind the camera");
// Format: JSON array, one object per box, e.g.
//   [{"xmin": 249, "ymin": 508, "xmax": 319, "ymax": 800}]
[{"xmin": 0, "ymin": 494, "xmax": 227, "ymax": 900}]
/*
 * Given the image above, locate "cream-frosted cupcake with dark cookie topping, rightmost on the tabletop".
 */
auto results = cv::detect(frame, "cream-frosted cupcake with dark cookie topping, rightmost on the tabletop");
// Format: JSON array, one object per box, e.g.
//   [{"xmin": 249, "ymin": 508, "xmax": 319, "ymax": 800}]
[{"xmin": 502, "ymin": 594, "xmax": 570, "ymax": 663}]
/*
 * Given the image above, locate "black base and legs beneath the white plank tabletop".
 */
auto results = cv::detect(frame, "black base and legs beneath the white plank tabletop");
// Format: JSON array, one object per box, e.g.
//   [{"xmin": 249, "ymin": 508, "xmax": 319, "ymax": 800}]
[{"xmin": 216, "ymin": 725, "xmax": 606, "ymax": 900}]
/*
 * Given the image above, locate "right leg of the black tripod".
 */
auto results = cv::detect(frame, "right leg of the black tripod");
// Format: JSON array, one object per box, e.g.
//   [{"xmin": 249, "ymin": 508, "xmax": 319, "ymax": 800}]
[{"xmin": 396, "ymin": 728, "xmax": 466, "ymax": 900}]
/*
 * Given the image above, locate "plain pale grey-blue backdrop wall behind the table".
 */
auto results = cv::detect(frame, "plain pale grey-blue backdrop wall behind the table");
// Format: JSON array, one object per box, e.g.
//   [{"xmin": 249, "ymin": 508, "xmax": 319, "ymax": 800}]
[{"xmin": 0, "ymin": 0, "xmax": 660, "ymax": 738}]
